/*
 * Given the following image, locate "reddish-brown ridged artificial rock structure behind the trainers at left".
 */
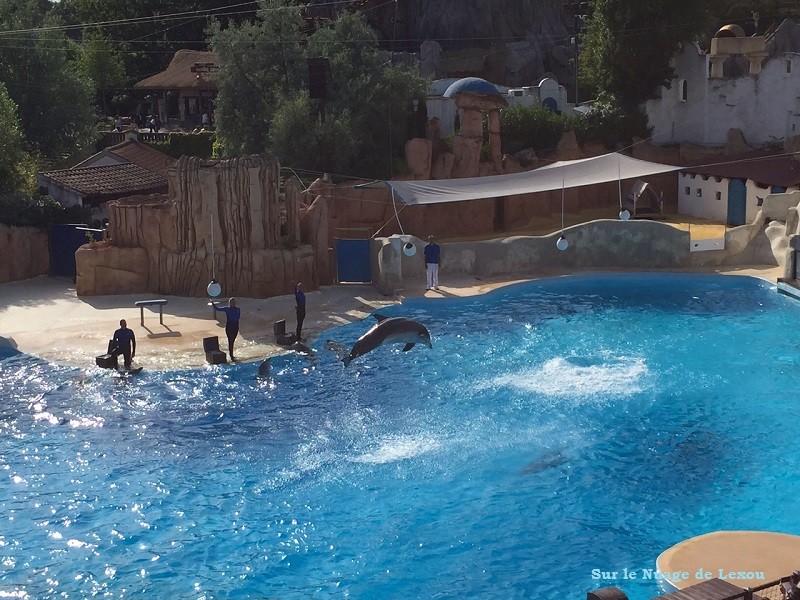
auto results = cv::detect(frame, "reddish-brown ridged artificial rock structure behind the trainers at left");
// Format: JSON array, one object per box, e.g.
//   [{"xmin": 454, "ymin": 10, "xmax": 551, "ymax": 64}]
[{"xmin": 75, "ymin": 156, "xmax": 318, "ymax": 298}]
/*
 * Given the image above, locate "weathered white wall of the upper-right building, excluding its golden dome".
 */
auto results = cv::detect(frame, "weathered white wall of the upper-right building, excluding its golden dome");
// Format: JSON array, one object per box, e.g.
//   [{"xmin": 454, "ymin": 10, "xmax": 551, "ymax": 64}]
[{"xmin": 645, "ymin": 44, "xmax": 800, "ymax": 146}]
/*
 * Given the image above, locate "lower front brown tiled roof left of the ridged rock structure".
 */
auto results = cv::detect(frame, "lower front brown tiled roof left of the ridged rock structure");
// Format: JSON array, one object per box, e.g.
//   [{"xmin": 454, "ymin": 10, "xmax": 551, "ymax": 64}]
[{"xmin": 40, "ymin": 163, "xmax": 167, "ymax": 202}]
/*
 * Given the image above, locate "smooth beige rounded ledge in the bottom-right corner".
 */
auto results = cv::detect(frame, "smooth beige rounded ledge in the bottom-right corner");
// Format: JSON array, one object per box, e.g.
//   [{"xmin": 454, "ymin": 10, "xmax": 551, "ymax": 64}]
[{"xmin": 656, "ymin": 531, "xmax": 800, "ymax": 590}]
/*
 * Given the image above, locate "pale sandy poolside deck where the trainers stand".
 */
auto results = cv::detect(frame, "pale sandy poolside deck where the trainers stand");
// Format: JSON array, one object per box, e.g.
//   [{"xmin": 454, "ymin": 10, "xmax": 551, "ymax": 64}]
[{"xmin": 0, "ymin": 266, "xmax": 783, "ymax": 369}]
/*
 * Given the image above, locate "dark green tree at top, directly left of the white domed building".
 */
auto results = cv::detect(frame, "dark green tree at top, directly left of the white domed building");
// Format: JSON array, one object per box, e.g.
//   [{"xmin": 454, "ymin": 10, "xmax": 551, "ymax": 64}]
[{"xmin": 580, "ymin": 0, "xmax": 715, "ymax": 110}]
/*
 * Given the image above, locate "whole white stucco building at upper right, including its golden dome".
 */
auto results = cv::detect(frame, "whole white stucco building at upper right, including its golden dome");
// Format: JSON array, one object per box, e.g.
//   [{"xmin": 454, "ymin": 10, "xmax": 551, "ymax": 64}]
[{"xmin": 645, "ymin": 20, "xmax": 800, "ymax": 146}]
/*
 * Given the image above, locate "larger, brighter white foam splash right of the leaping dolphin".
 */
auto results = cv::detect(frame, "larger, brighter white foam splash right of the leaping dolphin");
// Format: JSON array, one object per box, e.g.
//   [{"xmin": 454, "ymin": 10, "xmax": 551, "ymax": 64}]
[{"xmin": 493, "ymin": 356, "xmax": 649, "ymax": 398}]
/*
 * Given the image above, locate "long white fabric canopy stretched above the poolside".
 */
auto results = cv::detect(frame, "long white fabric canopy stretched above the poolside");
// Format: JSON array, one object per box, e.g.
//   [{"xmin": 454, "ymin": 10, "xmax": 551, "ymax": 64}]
[{"xmin": 384, "ymin": 152, "xmax": 685, "ymax": 204}]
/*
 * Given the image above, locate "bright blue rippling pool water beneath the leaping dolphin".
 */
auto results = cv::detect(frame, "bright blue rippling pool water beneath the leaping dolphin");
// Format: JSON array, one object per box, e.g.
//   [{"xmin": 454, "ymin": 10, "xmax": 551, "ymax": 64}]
[{"xmin": 0, "ymin": 274, "xmax": 800, "ymax": 600}]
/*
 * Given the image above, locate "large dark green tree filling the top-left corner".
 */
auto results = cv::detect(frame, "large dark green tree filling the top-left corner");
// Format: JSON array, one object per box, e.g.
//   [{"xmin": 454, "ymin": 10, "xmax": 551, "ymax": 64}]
[{"xmin": 0, "ymin": 0, "xmax": 94, "ymax": 157}]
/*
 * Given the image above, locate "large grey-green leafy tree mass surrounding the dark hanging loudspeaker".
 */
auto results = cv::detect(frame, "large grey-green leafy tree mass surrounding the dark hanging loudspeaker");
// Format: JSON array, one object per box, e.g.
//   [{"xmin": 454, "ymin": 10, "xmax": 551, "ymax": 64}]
[{"xmin": 212, "ymin": 0, "xmax": 425, "ymax": 177}]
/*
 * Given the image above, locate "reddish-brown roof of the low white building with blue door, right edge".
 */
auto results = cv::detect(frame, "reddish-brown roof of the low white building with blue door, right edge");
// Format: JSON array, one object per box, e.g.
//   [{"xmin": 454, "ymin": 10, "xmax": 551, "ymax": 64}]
[{"xmin": 684, "ymin": 154, "xmax": 800, "ymax": 187}]
